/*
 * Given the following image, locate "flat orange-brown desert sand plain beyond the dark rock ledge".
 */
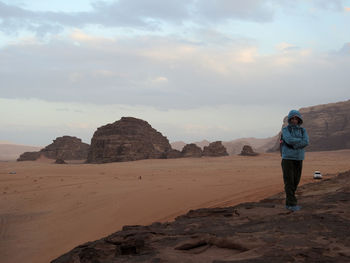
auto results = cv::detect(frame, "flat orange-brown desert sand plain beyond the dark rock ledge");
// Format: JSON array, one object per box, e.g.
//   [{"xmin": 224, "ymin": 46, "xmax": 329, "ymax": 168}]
[{"xmin": 0, "ymin": 150, "xmax": 350, "ymax": 263}]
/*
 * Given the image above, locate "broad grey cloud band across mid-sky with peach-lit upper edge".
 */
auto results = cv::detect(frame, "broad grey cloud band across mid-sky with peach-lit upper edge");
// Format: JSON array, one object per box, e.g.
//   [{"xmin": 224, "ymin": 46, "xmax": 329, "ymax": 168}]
[{"xmin": 0, "ymin": 33, "xmax": 350, "ymax": 110}]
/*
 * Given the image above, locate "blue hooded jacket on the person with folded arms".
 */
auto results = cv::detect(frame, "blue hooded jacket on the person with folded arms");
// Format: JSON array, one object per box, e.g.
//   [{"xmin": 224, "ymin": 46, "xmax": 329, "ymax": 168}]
[{"xmin": 282, "ymin": 110, "xmax": 309, "ymax": 160}]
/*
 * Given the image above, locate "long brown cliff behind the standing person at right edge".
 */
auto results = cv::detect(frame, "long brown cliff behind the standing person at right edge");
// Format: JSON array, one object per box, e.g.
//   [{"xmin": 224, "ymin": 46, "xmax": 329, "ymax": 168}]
[{"xmin": 269, "ymin": 100, "xmax": 350, "ymax": 151}]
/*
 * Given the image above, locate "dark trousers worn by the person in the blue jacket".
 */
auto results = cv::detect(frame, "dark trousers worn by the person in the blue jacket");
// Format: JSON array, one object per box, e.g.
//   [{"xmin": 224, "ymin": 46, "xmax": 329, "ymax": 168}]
[{"xmin": 282, "ymin": 159, "xmax": 303, "ymax": 206}]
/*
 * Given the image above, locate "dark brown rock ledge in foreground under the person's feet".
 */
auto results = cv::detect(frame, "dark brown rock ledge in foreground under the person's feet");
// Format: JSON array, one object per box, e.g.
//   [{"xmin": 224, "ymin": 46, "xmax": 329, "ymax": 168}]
[{"xmin": 52, "ymin": 171, "xmax": 350, "ymax": 263}]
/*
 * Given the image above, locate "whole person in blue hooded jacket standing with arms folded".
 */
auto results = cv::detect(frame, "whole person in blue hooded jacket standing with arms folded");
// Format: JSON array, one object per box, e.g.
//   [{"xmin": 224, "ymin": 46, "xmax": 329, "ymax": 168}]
[{"xmin": 281, "ymin": 110, "xmax": 309, "ymax": 211}]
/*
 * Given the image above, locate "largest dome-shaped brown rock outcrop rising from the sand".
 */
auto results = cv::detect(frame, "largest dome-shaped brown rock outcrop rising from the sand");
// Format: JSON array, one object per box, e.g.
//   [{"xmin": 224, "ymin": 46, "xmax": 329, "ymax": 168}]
[{"xmin": 87, "ymin": 117, "xmax": 171, "ymax": 163}]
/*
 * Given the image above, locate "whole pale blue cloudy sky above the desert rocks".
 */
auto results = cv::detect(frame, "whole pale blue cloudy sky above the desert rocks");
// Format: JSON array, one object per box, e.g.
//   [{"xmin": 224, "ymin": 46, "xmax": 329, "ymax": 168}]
[{"xmin": 0, "ymin": 0, "xmax": 350, "ymax": 146}]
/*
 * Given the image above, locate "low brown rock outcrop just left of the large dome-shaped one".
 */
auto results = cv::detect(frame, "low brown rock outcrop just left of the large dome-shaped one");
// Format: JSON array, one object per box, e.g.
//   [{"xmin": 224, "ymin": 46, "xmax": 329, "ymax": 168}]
[{"xmin": 17, "ymin": 136, "xmax": 89, "ymax": 161}]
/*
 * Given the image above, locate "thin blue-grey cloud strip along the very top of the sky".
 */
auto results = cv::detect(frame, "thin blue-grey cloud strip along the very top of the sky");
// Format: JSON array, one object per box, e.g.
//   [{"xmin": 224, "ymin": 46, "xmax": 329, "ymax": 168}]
[{"xmin": 0, "ymin": 0, "xmax": 344, "ymax": 36}]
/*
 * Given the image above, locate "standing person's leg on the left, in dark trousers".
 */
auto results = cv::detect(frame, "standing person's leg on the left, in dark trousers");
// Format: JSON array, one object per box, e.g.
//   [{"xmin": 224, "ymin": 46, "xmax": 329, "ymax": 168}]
[{"xmin": 282, "ymin": 159, "xmax": 296, "ymax": 206}]
